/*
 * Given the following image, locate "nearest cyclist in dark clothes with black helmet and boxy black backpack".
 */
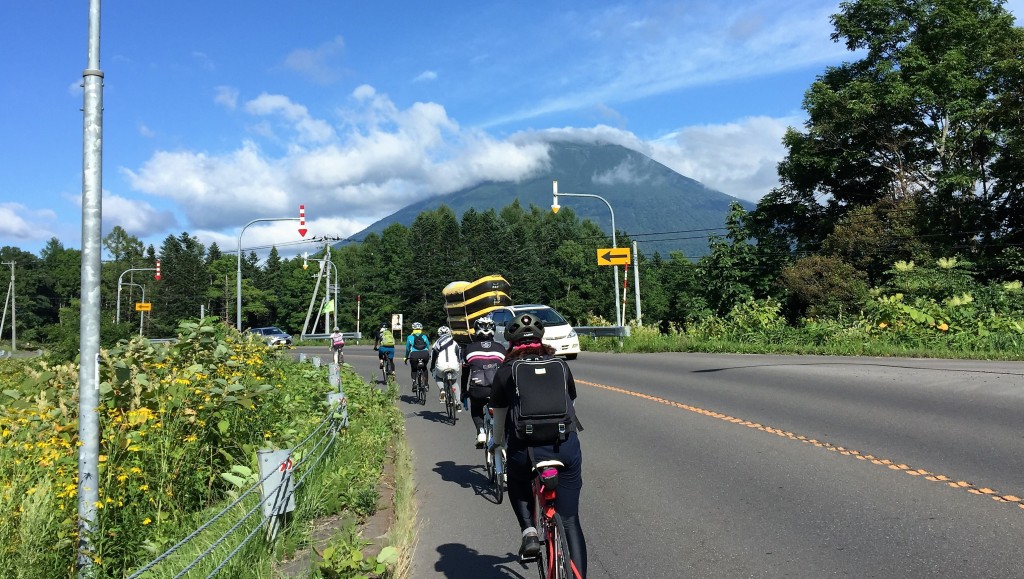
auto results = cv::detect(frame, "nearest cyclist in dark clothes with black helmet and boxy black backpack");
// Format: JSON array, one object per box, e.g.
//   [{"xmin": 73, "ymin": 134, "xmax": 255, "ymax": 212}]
[{"xmin": 490, "ymin": 314, "xmax": 587, "ymax": 578}]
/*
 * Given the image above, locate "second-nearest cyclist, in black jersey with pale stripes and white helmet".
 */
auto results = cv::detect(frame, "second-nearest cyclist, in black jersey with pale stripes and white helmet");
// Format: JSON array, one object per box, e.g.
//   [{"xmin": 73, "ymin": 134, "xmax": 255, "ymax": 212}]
[{"xmin": 461, "ymin": 315, "xmax": 505, "ymax": 448}]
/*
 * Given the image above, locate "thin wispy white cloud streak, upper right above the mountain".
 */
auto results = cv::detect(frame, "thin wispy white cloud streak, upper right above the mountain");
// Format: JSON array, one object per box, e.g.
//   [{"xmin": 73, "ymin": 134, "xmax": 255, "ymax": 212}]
[{"xmin": 483, "ymin": 0, "xmax": 848, "ymax": 127}]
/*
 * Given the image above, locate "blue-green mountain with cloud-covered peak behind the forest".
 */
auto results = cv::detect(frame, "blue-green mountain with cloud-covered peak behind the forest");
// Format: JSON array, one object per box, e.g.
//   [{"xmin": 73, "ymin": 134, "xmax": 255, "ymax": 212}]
[{"xmin": 344, "ymin": 142, "xmax": 754, "ymax": 257}]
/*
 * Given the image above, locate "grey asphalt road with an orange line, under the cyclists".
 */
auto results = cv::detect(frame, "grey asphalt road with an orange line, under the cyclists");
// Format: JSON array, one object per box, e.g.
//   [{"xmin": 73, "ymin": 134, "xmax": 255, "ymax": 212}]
[{"xmin": 299, "ymin": 346, "xmax": 1024, "ymax": 579}]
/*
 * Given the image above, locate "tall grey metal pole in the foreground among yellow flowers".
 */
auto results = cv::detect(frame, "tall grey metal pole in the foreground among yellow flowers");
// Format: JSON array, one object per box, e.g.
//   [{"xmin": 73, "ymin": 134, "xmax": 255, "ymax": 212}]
[{"xmin": 78, "ymin": 0, "xmax": 103, "ymax": 577}]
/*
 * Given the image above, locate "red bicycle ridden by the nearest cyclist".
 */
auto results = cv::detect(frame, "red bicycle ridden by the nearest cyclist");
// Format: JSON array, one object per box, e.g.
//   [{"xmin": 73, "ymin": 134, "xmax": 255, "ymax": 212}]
[{"xmin": 529, "ymin": 449, "xmax": 580, "ymax": 579}]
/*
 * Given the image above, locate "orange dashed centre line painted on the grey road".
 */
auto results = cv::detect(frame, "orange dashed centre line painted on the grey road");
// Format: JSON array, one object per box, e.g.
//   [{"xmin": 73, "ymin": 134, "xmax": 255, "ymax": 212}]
[{"xmin": 575, "ymin": 378, "xmax": 1024, "ymax": 509}]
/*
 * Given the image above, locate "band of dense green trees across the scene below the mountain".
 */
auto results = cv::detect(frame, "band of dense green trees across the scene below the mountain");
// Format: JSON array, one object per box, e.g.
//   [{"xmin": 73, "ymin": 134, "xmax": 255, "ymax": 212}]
[{"xmin": 0, "ymin": 0, "xmax": 1024, "ymax": 354}]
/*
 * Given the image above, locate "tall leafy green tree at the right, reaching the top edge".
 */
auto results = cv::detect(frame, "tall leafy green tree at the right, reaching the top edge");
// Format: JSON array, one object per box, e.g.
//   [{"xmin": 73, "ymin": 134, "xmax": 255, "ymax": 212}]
[{"xmin": 758, "ymin": 0, "xmax": 1024, "ymax": 262}]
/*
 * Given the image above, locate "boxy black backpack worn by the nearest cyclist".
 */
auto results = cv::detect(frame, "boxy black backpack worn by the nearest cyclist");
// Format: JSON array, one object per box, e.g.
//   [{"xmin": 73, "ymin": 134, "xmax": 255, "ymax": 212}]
[{"xmin": 510, "ymin": 358, "xmax": 575, "ymax": 446}]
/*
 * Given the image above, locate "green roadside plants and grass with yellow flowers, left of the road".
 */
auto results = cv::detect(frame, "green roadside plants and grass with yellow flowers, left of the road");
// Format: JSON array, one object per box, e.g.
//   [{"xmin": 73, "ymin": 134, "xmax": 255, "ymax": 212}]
[{"xmin": 0, "ymin": 318, "xmax": 401, "ymax": 578}]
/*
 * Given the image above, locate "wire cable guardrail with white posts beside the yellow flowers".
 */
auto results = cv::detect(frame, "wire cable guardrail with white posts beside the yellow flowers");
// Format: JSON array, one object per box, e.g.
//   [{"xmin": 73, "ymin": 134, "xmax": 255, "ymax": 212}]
[{"xmin": 127, "ymin": 358, "xmax": 348, "ymax": 579}]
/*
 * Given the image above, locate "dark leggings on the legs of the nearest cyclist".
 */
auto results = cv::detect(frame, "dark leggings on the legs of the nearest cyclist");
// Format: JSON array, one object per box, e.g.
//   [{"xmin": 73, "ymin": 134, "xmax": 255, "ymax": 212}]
[{"xmin": 506, "ymin": 432, "xmax": 587, "ymax": 578}]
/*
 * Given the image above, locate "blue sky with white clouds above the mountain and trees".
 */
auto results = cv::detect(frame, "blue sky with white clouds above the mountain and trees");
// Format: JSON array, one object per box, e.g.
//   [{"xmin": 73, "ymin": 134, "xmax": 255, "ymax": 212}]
[{"xmin": 0, "ymin": 0, "xmax": 1024, "ymax": 253}]
